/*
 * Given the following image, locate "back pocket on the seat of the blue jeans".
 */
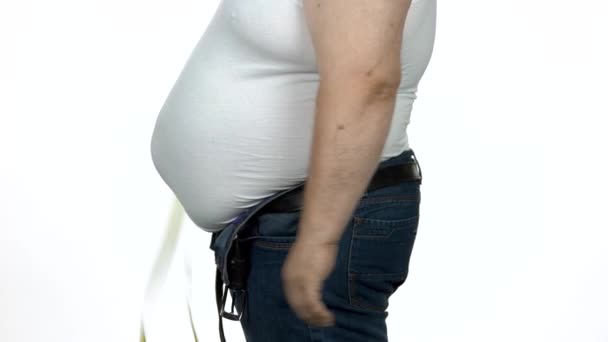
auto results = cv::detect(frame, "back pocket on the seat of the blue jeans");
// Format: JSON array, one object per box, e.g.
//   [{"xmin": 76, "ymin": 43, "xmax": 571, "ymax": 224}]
[{"xmin": 348, "ymin": 208, "xmax": 419, "ymax": 312}]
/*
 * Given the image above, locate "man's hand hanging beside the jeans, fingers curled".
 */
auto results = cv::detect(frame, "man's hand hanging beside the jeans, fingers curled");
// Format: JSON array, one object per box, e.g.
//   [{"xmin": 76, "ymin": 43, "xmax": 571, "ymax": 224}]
[{"xmin": 281, "ymin": 237, "xmax": 338, "ymax": 326}]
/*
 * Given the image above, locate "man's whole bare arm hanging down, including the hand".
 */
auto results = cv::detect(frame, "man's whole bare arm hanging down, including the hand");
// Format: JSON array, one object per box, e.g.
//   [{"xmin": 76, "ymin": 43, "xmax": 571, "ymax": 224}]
[{"xmin": 281, "ymin": 0, "xmax": 411, "ymax": 326}]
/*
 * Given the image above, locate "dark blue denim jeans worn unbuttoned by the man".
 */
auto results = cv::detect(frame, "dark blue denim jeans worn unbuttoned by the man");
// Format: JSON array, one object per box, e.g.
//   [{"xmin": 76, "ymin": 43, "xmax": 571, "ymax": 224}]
[{"xmin": 231, "ymin": 149, "xmax": 421, "ymax": 342}]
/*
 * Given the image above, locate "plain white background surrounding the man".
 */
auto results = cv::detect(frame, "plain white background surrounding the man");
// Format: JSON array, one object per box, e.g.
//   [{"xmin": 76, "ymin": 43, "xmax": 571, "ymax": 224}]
[{"xmin": 0, "ymin": 0, "xmax": 608, "ymax": 342}]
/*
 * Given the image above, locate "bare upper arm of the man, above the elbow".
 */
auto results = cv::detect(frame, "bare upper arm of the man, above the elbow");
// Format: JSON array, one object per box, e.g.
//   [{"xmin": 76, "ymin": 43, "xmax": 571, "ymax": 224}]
[{"xmin": 303, "ymin": 0, "xmax": 411, "ymax": 85}]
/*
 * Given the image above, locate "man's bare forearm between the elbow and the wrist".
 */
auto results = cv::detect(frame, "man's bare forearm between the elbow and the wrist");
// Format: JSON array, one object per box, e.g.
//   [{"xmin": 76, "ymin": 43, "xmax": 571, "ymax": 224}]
[{"xmin": 297, "ymin": 79, "xmax": 396, "ymax": 243}]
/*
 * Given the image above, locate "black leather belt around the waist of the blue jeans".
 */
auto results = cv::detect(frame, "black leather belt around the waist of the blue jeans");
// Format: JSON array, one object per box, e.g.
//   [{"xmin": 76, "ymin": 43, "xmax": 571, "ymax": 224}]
[{"xmin": 260, "ymin": 161, "xmax": 422, "ymax": 215}]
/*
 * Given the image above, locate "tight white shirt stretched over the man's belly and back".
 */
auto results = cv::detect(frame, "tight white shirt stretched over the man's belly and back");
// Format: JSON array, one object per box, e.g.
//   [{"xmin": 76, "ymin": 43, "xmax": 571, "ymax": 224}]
[{"xmin": 150, "ymin": 0, "xmax": 436, "ymax": 232}]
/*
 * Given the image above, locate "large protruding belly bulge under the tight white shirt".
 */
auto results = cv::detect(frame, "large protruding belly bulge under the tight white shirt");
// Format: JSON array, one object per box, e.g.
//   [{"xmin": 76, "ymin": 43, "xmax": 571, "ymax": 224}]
[{"xmin": 151, "ymin": 68, "xmax": 314, "ymax": 231}]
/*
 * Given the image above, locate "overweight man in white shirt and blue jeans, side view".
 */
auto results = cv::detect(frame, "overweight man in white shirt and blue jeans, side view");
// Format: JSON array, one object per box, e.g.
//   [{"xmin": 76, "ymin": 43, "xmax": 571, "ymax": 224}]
[{"xmin": 152, "ymin": 0, "xmax": 436, "ymax": 342}]
